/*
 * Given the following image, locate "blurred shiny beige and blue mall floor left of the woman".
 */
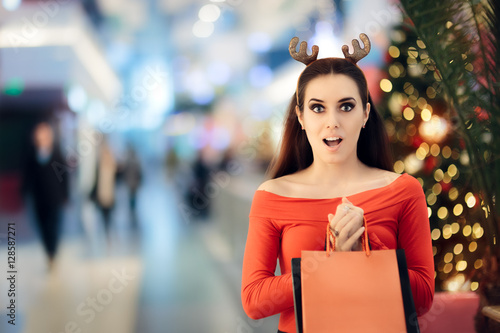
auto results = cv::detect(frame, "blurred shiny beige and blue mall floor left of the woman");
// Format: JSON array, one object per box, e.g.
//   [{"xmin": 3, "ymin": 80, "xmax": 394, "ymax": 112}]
[{"xmin": 0, "ymin": 158, "xmax": 277, "ymax": 333}]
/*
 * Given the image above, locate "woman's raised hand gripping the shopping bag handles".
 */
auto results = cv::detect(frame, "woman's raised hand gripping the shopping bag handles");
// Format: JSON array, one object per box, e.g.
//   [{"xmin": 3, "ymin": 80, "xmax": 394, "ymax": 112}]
[{"xmin": 328, "ymin": 197, "xmax": 365, "ymax": 251}]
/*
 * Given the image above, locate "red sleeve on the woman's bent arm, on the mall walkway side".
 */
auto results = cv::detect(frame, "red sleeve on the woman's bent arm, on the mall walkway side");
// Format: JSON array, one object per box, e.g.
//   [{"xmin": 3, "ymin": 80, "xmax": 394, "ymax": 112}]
[{"xmin": 241, "ymin": 216, "xmax": 293, "ymax": 319}]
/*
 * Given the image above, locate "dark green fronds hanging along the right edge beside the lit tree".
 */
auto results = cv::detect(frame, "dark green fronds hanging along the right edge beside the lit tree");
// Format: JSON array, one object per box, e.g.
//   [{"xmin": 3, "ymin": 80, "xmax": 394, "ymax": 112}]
[{"xmin": 401, "ymin": 0, "xmax": 500, "ymax": 257}]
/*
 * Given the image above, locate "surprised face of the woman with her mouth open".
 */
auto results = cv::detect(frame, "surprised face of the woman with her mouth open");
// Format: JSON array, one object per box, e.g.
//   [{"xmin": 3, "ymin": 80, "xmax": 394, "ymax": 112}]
[{"xmin": 296, "ymin": 74, "xmax": 370, "ymax": 164}]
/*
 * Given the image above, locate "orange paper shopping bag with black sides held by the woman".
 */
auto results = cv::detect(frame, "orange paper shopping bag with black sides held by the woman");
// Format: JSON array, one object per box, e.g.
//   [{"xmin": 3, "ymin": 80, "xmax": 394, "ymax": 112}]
[{"xmin": 292, "ymin": 223, "xmax": 419, "ymax": 333}]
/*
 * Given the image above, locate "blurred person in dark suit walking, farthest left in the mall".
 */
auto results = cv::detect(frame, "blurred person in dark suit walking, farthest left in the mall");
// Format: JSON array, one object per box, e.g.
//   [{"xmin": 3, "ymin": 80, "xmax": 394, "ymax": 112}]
[{"xmin": 23, "ymin": 122, "xmax": 69, "ymax": 269}]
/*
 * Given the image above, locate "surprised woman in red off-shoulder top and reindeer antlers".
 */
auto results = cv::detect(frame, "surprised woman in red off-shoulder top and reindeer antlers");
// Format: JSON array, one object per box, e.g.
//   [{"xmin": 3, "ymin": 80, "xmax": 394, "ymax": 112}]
[{"xmin": 242, "ymin": 34, "xmax": 434, "ymax": 332}]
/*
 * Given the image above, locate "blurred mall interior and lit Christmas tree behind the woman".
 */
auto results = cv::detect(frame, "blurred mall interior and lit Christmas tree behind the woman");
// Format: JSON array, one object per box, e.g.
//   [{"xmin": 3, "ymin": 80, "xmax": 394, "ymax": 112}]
[{"xmin": 0, "ymin": 0, "xmax": 485, "ymax": 333}]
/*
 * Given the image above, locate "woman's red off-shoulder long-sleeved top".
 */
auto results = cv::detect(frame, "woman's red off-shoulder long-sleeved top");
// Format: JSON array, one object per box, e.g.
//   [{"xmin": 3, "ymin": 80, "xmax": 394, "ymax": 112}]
[{"xmin": 241, "ymin": 174, "xmax": 434, "ymax": 332}]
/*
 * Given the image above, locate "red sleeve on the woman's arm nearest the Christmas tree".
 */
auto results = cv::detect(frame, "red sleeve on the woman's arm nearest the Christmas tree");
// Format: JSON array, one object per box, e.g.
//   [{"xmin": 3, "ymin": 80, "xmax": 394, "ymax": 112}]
[{"xmin": 398, "ymin": 179, "xmax": 434, "ymax": 316}]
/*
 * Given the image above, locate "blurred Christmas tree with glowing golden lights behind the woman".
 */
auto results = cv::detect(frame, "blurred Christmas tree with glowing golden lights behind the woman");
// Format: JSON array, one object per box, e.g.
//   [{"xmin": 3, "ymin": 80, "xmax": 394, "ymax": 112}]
[{"xmin": 378, "ymin": 23, "xmax": 487, "ymax": 291}]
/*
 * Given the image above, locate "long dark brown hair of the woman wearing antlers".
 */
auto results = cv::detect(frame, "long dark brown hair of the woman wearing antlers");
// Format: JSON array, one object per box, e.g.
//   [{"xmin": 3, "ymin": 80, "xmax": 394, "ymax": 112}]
[{"xmin": 268, "ymin": 58, "xmax": 393, "ymax": 178}]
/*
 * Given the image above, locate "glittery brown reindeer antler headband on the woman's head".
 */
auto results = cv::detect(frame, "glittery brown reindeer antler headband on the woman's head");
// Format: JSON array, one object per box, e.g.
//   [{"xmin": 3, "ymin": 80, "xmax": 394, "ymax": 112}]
[{"xmin": 288, "ymin": 33, "xmax": 371, "ymax": 104}]
